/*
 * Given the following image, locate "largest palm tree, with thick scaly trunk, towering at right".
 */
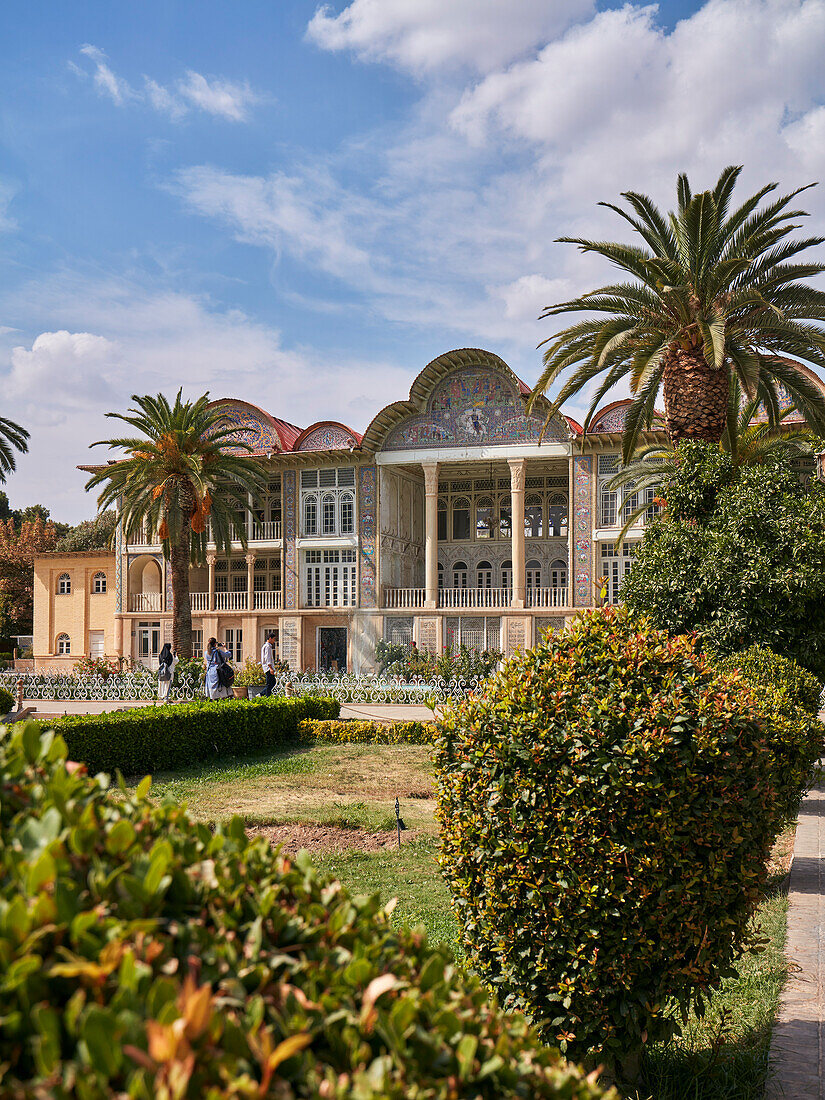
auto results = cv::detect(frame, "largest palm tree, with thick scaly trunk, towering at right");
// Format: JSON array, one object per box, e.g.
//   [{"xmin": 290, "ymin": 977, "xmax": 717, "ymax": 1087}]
[{"xmin": 531, "ymin": 166, "xmax": 825, "ymax": 462}]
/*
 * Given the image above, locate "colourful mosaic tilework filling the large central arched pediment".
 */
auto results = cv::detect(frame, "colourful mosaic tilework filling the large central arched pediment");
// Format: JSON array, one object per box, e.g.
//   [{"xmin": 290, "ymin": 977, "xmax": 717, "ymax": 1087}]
[{"xmin": 384, "ymin": 367, "xmax": 568, "ymax": 451}]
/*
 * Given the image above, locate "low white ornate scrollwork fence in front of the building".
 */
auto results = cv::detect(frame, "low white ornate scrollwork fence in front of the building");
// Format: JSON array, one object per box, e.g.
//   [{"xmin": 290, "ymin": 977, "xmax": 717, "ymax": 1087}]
[{"xmin": 0, "ymin": 671, "xmax": 484, "ymax": 704}]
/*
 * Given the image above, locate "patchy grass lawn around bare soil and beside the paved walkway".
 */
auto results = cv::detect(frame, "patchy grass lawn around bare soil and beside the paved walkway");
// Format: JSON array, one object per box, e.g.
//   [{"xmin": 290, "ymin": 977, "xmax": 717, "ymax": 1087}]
[{"xmin": 140, "ymin": 745, "xmax": 792, "ymax": 1100}]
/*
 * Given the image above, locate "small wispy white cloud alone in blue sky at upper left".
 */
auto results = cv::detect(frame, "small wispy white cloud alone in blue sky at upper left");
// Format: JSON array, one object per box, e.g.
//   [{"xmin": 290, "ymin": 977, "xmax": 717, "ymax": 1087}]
[{"xmin": 69, "ymin": 45, "xmax": 261, "ymax": 122}]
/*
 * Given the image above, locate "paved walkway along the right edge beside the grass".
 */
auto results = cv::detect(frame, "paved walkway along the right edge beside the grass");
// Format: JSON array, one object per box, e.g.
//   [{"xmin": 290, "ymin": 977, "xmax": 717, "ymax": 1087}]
[{"xmin": 766, "ymin": 765, "xmax": 825, "ymax": 1100}]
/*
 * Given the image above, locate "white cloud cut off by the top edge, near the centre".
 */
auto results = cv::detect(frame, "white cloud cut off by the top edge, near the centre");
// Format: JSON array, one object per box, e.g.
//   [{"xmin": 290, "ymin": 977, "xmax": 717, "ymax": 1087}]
[{"xmin": 307, "ymin": 0, "xmax": 594, "ymax": 75}]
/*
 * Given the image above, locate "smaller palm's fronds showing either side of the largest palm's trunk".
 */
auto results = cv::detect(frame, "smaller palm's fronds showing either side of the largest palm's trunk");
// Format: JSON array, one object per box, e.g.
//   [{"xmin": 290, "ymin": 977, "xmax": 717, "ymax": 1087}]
[{"xmin": 605, "ymin": 375, "xmax": 821, "ymax": 542}]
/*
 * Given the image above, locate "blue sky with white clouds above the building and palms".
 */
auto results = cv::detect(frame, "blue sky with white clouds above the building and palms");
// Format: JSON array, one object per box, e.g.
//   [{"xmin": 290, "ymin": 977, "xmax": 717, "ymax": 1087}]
[{"xmin": 0, "ymin": 0, "xmax": 825, "ymax": 520}]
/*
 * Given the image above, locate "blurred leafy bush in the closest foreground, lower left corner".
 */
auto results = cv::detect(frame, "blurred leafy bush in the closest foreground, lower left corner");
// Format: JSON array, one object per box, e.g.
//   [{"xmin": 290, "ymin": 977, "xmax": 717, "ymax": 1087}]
[{"xmin": 0, "ymin": 724, "xmax": 615, "ymax": 1100}]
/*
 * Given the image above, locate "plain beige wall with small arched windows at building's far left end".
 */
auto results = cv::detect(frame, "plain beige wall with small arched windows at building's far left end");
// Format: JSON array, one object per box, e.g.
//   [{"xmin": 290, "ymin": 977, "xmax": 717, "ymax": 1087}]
[{"xmin": 33, "ymin": 551, "xmax": 118, "ymax": 669}]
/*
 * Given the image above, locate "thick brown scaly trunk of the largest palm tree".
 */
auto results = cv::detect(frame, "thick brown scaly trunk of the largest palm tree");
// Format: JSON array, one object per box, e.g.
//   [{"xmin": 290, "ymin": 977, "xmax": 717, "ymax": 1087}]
[{"xmin": 664, "ymin": 345, "xmax": 729, "ymax": 447}]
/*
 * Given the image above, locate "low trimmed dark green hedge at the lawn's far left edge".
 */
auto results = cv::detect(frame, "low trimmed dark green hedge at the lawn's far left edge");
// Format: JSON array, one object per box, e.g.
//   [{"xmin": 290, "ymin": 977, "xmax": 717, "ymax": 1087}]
[{"xmin": 41, "ymin": 695, "xmax": 341, "ymax": 776}]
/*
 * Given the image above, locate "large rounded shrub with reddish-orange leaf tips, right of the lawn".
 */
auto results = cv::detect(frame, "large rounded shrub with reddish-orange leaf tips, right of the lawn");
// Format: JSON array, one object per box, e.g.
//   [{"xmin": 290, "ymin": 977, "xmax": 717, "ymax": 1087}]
[{"xmin": 435, "ymin": 608, "xmax": 779, "ymax": 1073}]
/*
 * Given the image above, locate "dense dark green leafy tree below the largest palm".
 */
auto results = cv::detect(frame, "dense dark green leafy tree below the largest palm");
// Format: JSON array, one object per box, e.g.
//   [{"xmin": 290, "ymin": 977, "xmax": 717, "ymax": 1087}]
[{"xmin": 622, "ymin": 443, "xmax": 825, "ymax": 680}]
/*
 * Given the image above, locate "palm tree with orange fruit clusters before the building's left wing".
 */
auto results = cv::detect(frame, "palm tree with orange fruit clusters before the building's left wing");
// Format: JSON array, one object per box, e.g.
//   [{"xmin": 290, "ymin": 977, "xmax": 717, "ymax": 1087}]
[{"xmin": 86, "ymin": 389, "xmax": 265, "ymax": 657}]
